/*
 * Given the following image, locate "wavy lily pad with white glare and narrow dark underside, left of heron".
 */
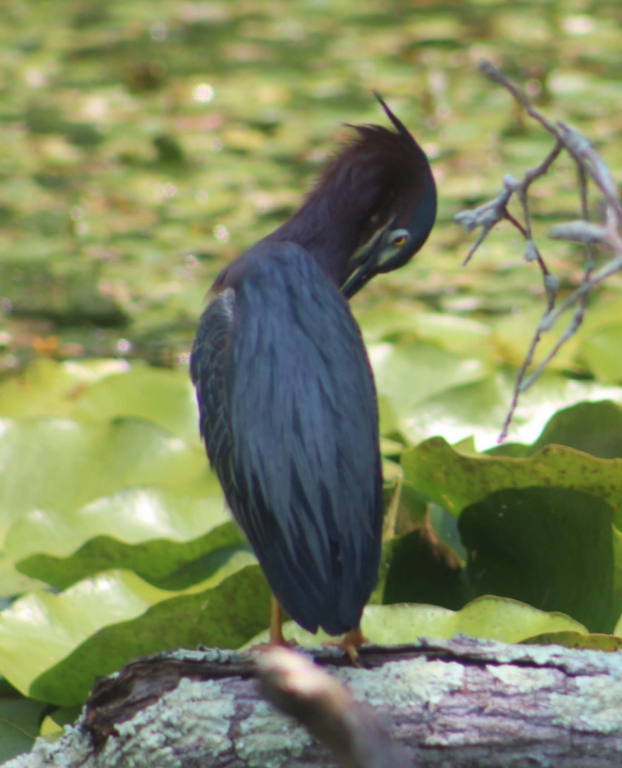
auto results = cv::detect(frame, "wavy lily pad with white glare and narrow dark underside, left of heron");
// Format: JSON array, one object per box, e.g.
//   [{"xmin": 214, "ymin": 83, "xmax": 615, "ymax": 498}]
[{"xmin": 6, "ymin": 488, "xmax": 241, "ymax": 589}]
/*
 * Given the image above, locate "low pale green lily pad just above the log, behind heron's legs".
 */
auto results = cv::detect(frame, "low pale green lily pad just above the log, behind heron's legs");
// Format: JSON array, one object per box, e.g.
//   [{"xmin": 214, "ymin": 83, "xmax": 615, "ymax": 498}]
[{"xmin": 248, "ymin": 597, "xmax": 587, "ymax": 646}]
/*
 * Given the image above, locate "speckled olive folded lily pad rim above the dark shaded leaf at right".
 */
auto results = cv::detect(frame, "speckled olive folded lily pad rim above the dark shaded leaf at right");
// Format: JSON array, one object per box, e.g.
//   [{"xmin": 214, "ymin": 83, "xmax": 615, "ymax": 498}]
[{"xmin": 402, "ymin": 437, "xmax": 622, "ymax": 525}]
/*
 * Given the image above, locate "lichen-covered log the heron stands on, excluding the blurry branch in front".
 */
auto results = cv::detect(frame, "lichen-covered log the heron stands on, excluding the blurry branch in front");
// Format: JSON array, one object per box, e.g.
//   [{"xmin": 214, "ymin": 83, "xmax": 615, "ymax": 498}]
[{"xmin": 5, "ymin": 636, "xmax": 622, "ymax": 768}]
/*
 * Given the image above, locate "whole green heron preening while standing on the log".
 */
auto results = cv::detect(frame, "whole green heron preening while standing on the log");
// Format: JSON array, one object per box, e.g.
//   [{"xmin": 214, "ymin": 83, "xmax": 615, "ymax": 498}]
[{"xmin": 190, "ymin": 96, "xmax": 436, "ymax": 655}]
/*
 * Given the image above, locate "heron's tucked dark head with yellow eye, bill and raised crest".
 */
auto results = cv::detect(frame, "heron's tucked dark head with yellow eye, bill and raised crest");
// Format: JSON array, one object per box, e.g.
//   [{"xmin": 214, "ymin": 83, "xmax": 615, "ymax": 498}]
[{"xmin": 342, "ymin": 94, "xmax": 436, "ymax": 298}]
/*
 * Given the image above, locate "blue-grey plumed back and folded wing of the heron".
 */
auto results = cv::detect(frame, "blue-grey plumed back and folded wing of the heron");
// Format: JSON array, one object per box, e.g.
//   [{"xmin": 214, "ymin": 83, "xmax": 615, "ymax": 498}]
[{"xmin": 219, "ymin": 243, "xmax": 382, "ymax": 634}]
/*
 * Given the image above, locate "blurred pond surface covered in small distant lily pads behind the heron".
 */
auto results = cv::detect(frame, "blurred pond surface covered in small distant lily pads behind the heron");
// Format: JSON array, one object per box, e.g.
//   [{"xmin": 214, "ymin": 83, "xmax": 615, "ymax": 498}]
[{"xmin": 0, "ymin": 0, "xmax": 622, "ymax": 390}]
